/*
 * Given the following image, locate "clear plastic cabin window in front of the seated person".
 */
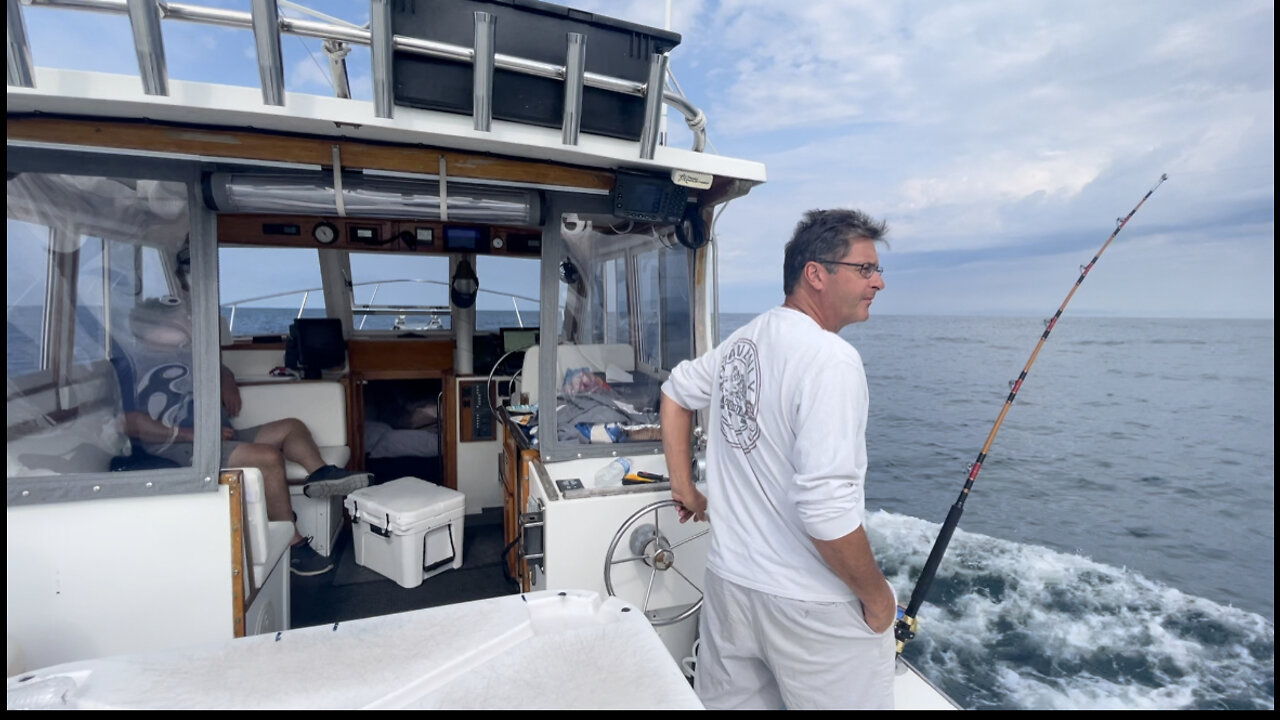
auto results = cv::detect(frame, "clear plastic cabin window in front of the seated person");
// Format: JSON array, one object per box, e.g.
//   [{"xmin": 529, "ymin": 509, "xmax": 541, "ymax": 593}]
[{"xmin": 6, "ymin": 173, "xmax": 209, "ymax": 501}]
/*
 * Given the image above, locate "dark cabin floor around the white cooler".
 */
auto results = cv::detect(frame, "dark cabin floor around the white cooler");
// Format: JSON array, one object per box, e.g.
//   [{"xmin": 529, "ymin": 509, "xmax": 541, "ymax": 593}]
[{"xmin": 291, "ymin": 515, "xmax": 517, "ymax": 628}]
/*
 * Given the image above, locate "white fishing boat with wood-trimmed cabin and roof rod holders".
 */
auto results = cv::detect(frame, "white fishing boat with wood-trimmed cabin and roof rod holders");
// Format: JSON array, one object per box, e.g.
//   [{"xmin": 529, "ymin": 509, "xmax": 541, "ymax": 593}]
[{"xmin": 6, "ymin": 0, "xmax": 955, "ymax": 708}]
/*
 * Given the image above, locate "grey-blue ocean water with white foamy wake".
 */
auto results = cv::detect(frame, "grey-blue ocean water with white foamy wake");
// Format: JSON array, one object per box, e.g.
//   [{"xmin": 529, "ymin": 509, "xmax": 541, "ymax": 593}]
[{"xmin": 721, "ymin": 315, "xmax": 1275, "ymax": 710}]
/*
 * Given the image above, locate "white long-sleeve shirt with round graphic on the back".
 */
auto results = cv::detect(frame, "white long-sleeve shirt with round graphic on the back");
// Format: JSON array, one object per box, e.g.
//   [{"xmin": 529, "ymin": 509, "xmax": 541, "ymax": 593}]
[{"xmin": 662, "ymin": 307, "xmax": 869, "ymax": 602}]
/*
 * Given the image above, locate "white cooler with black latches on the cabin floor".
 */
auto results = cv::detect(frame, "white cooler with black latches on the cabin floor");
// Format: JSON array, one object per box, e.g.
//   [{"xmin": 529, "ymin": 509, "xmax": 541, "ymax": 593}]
[{"xmin": 344, "ymin": 478, "xmax": 466, "ymax": 588}]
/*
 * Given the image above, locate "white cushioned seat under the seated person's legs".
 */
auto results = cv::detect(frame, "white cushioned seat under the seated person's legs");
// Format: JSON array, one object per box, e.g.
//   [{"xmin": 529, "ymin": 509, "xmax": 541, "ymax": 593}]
[{"xmin": 232, "ymin": 380, "xmax": 351, "ymax": 557}]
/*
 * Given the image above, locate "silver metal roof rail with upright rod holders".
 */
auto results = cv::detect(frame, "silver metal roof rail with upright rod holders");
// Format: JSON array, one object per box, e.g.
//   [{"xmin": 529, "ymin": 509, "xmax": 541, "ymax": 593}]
[{"xmin": 5, "ymin": 0, "xmax": 707, "ymax": 160}]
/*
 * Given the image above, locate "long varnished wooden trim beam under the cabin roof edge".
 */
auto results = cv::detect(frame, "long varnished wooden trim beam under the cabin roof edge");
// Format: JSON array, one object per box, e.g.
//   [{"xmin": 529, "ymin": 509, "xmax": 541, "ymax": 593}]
[{"xmin": 6, "ymin": 115, "xmax": 613, "ymax": 191}]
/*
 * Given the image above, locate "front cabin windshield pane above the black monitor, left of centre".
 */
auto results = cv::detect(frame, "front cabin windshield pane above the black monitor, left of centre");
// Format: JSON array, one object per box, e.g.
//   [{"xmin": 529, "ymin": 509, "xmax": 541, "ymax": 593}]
[{"xmin": 218, "ymin": 245, "xmax": 325, "ymax": 337}]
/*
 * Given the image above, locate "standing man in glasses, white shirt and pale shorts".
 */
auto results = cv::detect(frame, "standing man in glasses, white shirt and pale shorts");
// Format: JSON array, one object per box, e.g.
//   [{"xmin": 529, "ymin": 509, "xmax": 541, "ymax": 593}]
[{"xmin": 662, "ymin": 209, "xmax": 897, "ymax": 710}]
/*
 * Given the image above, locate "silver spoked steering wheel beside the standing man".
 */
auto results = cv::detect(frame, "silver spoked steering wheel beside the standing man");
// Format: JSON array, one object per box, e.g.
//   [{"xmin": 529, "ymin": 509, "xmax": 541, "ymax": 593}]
[{"xmin": 604, "ymin": 498, "xmax": 710, "ymax": 626}]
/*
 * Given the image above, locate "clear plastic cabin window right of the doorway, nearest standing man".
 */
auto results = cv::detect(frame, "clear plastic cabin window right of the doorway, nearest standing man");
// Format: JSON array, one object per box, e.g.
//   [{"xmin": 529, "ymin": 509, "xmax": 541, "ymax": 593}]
[{"xmin": 539, "ymin": 217, "xmax": 694, "ymax": 459}]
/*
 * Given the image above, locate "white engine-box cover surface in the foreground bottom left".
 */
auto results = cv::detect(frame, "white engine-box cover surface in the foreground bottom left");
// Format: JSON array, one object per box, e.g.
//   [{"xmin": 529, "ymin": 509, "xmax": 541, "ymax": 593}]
[{"xmin": 8, "ymin": 591, "xmax": 701, "ymax": 710}]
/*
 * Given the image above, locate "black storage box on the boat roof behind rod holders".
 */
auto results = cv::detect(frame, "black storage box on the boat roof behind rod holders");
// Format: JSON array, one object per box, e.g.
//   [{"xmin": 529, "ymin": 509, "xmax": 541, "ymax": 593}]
[{"xmin": 392, "ymin": 0, "xmax": 680, "ymax": 140}]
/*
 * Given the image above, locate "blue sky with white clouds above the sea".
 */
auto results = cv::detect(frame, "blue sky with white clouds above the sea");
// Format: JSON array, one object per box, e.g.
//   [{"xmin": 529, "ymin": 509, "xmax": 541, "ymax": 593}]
[{"xmin": 15, "ymin": 0, "xmax": 1275, "ymax": 318}]
